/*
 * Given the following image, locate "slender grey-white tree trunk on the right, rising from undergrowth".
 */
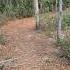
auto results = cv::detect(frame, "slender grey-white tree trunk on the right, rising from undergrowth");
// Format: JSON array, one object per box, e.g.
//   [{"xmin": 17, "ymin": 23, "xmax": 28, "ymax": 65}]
[{"xmin": 56, "ymin": 0, "xmax": 63, "ymax": 39}]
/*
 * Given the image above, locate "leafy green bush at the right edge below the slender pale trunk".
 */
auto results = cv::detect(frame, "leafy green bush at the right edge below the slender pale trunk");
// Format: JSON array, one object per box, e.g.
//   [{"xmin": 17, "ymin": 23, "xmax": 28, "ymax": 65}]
[{"xmin": 58, "ymin": 38, "xmax": 70, "ymax": 60}]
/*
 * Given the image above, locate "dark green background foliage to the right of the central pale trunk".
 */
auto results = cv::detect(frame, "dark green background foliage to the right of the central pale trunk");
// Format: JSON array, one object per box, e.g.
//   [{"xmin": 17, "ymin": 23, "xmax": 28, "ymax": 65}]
[{"xmin": 39, "ymin": 0, "xmax": 70, "ymax": 12}]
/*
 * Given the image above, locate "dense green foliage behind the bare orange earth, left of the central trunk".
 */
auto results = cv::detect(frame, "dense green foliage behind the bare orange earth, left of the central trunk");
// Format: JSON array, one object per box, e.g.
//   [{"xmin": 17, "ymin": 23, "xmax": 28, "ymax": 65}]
[{"xmin": 0, "ymin": 0, "xmax": 33, "ymax": 17}]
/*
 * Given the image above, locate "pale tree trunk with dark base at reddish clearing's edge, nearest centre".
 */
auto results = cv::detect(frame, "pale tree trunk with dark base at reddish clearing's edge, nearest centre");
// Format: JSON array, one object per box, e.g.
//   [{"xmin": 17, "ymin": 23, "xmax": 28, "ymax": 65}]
[{"xmin": 34, "ymin": 0, "xmax": 40, "ymax": 29}]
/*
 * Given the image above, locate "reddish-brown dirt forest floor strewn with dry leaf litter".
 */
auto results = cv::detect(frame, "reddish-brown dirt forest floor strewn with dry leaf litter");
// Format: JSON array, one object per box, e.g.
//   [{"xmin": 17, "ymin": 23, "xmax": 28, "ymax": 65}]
[{"xmin": 0, "ymin": 17, "xmax": 70, "ymax": 70}]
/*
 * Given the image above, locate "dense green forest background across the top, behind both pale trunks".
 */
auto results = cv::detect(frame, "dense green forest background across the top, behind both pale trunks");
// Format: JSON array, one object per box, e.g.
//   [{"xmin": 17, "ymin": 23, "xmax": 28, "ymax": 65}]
[{"xmin": 0, "ymin": 0, "xmax": 70, "ymax": 17}]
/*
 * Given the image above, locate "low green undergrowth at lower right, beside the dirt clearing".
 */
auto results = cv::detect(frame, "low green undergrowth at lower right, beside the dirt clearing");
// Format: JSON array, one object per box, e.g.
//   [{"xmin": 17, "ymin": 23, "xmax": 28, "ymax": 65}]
[{"xmin": 58, "ymin": 33, "xmax": 70, "ymax": 64}]
